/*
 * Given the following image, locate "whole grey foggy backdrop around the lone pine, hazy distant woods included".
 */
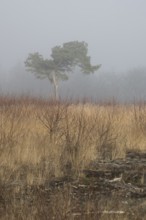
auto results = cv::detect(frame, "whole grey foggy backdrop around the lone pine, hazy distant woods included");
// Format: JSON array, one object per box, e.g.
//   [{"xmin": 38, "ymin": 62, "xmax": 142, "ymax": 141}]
[{"xmin": 0, "ymin": 0, "xmax": 146, "ymax": 101}]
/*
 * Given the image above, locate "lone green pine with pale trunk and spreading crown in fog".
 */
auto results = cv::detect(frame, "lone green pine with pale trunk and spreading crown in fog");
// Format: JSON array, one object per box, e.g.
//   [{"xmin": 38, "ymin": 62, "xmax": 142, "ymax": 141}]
[{"xmin": 25, "ymin": 41, "xmax": 100, "ymax": 99}]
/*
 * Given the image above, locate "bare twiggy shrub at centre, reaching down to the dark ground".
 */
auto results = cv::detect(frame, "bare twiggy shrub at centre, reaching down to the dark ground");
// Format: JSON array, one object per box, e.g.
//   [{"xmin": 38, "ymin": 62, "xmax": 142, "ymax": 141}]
[{"xmin": 61, "ymin": 106, "xmax": 89, "ymax": 175}]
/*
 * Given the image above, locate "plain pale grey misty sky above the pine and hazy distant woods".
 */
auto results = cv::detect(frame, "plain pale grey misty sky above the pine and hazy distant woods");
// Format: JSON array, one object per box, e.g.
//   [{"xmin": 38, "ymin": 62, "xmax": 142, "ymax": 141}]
[{"xmin": 0, "ymin": 0, "xmax": 146, "ymax": 71}]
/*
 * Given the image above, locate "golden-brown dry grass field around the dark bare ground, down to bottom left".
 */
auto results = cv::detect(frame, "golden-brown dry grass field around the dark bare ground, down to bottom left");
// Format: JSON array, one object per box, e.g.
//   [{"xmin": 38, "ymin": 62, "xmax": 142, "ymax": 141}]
[{"xmin": 0, "ymin": 96, "xmax": 146, "ymax": 220}]
